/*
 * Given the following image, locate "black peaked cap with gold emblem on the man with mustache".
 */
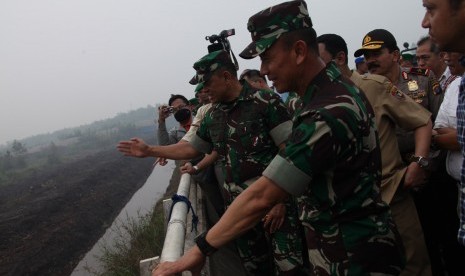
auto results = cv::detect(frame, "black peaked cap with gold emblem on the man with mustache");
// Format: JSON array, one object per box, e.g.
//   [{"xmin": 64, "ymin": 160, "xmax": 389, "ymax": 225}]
[{"xmin": 354, "ymin": 29, "xmax": 399, "ymax": 57}]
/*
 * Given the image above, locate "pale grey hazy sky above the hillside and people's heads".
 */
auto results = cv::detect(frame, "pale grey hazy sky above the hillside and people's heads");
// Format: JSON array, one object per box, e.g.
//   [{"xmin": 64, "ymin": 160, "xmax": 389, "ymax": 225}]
[{"xmin": 0, "ymin": 0, "xmax": 427, "ymax": 147}]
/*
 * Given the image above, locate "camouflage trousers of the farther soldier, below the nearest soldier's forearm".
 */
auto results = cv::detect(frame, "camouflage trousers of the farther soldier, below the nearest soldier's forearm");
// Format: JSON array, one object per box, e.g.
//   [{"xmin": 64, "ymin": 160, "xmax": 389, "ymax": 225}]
[{"xmin": 225, "ymin": 181, "xmax": 304, "ymax": 275}]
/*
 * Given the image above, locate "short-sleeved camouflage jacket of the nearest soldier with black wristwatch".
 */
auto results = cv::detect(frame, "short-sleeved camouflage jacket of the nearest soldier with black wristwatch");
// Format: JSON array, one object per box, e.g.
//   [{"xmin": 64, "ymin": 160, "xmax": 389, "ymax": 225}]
[{"xmin": 263, "ymin": 64, "xmax": 403, "ymax": 275}]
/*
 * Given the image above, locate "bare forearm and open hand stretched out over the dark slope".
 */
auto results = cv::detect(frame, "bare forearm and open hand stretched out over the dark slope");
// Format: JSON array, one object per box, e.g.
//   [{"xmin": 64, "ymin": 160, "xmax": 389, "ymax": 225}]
[{"xmin": 117, "ymin": 138, "xmax": 201, "ymax": 160}]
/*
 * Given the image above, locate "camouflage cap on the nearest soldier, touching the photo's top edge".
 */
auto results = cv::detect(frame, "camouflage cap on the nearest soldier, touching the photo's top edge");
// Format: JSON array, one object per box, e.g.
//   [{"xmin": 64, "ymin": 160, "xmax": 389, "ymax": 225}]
[{"xmin": 239, "ymin": 0, "xmax": 312, "ymax": 59}]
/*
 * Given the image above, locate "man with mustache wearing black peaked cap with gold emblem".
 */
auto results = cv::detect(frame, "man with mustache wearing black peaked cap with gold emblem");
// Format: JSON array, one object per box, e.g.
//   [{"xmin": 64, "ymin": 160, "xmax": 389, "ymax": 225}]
[{"xmin": 354, "ymin": 29, "xmax": 444, "ymax": 275}]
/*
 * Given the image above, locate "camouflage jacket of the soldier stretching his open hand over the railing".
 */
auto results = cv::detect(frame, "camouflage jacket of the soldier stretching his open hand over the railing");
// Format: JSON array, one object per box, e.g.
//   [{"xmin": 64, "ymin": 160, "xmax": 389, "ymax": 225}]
[{"xmin": 191, "ymin": 82, "xmax": 292, "ymax": 188}]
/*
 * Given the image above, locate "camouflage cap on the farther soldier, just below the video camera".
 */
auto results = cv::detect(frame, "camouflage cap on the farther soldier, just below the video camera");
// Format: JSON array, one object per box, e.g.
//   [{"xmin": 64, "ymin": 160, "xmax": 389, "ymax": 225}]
[{"xmin": 189, "ymin": 50, "xmax": 234, "ymax": 84}]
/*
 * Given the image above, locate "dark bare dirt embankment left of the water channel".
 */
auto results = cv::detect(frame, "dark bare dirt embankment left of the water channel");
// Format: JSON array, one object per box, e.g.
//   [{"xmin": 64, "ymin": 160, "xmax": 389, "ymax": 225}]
[{"xmin": 0, "ymin": 150, "xmax": 153, "ymax": 276}]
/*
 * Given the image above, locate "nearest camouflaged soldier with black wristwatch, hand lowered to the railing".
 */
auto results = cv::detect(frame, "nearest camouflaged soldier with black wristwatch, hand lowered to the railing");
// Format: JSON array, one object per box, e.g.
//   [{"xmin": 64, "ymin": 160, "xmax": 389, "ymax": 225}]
[{"xmin": 153, "ymin": 1, "xmax": 403, "ymax": 275}]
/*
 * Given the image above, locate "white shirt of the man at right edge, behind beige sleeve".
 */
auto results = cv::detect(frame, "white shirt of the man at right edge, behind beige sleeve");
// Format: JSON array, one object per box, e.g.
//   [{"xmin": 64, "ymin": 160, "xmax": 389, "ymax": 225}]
[{"xmin": 434, "ymin": 77, "xmax": 463, "ymax": 181}]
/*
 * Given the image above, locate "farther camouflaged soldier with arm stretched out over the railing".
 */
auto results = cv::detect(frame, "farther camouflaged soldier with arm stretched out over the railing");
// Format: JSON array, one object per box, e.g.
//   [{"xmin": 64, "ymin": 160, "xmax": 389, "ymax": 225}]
[{"xmin": 117, "ymin": 50, "xmax": 303, "ymax": 275}]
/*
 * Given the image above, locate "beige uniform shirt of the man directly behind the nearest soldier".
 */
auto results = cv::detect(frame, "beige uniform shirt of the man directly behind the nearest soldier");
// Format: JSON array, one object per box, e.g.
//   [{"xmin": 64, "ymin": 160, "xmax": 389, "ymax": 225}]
[{"xmin": 350, "ymin": 73, "xmax": 431, "ymax": 203}]
